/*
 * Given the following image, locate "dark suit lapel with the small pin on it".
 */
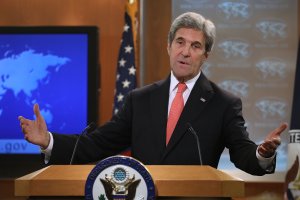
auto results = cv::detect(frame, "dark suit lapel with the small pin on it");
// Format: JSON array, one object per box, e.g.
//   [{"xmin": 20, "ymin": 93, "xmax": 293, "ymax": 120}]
[{"xmin": 162, "ymin": 73, "xmax": 213, "ymax": 159}]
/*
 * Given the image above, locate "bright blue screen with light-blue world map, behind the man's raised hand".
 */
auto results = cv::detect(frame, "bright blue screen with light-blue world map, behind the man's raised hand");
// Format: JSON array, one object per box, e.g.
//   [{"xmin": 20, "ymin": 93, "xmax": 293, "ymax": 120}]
[{"xmin": 0, "ymin": 34, "xmax": 88, "ymax": 154}]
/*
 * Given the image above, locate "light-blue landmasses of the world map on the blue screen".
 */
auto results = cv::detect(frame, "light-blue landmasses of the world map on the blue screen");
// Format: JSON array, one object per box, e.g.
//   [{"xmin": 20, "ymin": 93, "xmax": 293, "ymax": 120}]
[{"xmin": 0, "ymin": 49, "xmax": 70, "ymax": 124}]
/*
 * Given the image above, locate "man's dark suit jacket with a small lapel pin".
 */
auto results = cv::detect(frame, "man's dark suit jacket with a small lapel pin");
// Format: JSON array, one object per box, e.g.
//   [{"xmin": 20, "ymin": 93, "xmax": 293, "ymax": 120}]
[{"xmin": 50, "ymin": 73, "xmax": 274, "ymax": 175}]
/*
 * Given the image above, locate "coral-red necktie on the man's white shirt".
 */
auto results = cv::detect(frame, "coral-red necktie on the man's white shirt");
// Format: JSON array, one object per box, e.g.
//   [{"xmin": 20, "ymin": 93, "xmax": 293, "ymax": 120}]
[{"xmin": 166, "ymin": 83, "xmax": 186, "ymax": 144}]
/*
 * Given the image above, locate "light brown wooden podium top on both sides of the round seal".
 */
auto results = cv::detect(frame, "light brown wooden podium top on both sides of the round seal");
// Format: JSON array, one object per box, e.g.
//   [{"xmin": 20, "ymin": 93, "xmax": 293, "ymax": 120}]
[{"xmin": 15, "ymin": 165, "xmax": 245, "ymax": 199}]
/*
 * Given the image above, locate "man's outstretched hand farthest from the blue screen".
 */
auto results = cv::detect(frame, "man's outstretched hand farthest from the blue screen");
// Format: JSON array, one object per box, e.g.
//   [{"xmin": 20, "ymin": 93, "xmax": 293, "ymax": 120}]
[{"xmin": 258, "ymin": 123, "xmax": 288, "ymax": 158}]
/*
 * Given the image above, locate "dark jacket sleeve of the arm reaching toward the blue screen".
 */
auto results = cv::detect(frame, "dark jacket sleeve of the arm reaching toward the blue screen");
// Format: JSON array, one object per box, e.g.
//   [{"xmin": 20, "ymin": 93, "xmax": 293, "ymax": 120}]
[{"xmin": 49, "ymin": 94, "xmax": 131, "ymax": 164}]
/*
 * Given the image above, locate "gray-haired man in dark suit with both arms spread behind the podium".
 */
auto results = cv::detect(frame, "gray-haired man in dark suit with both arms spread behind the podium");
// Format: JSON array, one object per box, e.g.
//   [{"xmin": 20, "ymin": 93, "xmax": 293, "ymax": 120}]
[{"xmin": 19, "ymin": 12, "xmax": 287, "ymax": 175}]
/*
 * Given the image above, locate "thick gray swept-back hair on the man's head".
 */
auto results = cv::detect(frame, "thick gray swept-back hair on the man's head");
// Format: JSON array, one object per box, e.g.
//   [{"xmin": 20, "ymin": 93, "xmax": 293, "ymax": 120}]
[{"xmin": 168, "ymin": 12, "xmax": 216, "ymax": 52}]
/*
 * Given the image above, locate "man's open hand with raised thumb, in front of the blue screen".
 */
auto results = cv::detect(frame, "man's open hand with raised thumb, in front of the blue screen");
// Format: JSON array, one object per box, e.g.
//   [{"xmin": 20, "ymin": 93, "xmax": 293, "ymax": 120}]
[{"xmin": 18, "ymin": 104, "xmax": 50, "ymax": 149}]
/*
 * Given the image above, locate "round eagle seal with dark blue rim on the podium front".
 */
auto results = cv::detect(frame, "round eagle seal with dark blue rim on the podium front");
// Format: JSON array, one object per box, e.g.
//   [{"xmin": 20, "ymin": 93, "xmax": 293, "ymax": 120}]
[{"xmin": 85, "ymin": 156, "xmax": 155, "ymax": 200}]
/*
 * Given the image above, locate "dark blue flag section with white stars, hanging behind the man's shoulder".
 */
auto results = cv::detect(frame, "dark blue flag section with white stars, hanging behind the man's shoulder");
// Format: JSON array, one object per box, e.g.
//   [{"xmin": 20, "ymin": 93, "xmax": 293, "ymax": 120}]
[{"xmin": 113, "ymin": 2, "xmax": 137, "ymax": 114}]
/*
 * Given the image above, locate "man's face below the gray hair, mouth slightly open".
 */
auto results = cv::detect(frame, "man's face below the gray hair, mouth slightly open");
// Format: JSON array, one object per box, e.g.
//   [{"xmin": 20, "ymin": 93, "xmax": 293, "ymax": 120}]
[{"xmin": 168, "ymin": 28, "xmax": 208, "ymax": 81}]
